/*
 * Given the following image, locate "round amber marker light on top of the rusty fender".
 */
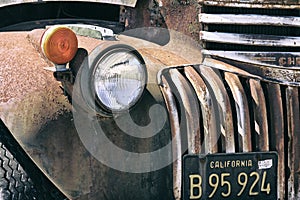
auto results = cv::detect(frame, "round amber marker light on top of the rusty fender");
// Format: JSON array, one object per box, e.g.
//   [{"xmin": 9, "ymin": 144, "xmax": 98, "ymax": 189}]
[{"xmin": 41, "ymin": 26, "xmax": 78, "ymax": 65}]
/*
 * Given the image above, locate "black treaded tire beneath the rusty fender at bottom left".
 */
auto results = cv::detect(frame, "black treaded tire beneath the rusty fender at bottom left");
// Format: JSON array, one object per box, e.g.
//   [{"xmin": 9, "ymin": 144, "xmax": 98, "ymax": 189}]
[{"xmin": 0, "ymin": 120, "xmax": 66, "ymax": 200}]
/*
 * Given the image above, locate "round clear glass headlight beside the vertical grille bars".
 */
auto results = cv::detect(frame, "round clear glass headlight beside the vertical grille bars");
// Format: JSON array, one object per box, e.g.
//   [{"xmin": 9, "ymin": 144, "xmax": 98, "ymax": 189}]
[{"xmin": 92, "ymin": 47, "xmax": 147, "ymax": 112}]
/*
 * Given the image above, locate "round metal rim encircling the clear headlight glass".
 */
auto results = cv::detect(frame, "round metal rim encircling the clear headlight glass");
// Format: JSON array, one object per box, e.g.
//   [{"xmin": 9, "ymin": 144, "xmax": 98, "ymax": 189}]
[{"xmin": 89, "ymin": 43, "xmax": 148, "ymax": 116}]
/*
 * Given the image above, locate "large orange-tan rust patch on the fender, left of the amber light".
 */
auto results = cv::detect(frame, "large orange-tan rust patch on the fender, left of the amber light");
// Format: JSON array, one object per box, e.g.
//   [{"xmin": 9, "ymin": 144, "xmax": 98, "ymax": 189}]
[{"xmin": 0, "ymin": 32, "xmax": 70, "ymax": 137}]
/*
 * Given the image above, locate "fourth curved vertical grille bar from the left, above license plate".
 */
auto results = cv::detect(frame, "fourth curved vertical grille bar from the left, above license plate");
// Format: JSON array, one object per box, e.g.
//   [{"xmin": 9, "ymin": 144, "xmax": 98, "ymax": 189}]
[{"xmin": 198, "ymin": 65, "xmax": 235, "ymax": 153}]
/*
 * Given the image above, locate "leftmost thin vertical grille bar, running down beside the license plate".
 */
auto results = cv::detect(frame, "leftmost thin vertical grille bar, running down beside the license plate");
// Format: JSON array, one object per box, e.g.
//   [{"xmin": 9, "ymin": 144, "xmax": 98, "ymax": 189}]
[{"xmin": 160, "ymin": 76, "xmax": 183, "ymax": 200}]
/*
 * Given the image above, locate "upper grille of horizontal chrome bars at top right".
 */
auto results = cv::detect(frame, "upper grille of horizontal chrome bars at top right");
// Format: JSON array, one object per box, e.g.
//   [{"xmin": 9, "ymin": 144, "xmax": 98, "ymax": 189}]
[{"xmin": 199, "ymin": 5, "xmax": 300, "ymax": 52}]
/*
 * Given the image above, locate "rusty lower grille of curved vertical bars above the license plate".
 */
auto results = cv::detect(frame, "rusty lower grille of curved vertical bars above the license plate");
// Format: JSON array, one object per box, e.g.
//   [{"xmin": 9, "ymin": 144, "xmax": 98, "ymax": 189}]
[{"xmin": 161, "ymin": 61, "xmax": 300, "ymax": 199}]
